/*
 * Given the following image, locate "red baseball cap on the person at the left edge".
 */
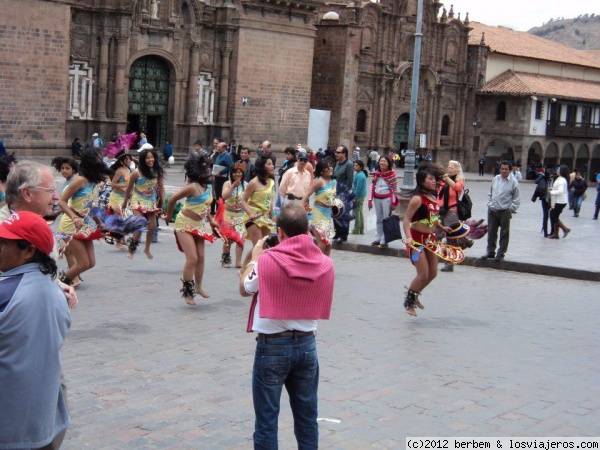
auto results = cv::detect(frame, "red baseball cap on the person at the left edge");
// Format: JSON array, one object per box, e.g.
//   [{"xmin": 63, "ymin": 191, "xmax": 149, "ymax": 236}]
[{"xmin": 0, "ymin": 211, "xmax": 54, "ymax": 255}]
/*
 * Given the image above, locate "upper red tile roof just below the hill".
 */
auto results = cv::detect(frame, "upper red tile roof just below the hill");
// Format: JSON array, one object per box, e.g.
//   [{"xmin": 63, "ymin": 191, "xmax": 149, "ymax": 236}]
[{"xmin": 469, "ymin": 22, "xmax": 600, "ymax": 69}]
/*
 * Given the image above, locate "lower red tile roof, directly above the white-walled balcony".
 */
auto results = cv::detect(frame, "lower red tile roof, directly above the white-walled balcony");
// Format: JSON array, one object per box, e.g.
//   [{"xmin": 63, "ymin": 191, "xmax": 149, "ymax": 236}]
[{"xmin": 479, "ymin": 70, "xmax": 600, "ymax": 102}]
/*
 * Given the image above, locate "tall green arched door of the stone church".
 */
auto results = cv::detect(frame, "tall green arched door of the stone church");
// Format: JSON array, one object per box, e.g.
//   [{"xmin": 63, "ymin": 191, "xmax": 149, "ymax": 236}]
[{"xmin": 127, "ymin": 55, "xmax": 171, "ymax": 147}]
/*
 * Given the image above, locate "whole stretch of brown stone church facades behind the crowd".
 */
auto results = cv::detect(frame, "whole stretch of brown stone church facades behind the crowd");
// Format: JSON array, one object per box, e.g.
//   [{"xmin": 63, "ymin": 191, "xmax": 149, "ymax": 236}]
[{"xmin": 0, "ymin": 0, "xmax": 474, "ymax": 160}]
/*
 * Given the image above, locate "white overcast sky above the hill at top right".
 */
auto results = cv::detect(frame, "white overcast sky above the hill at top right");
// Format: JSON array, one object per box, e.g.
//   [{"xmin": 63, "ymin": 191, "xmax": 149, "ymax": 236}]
[{"xmin": 440, "ymin": 0, "xmax": 600, "ymax": 31}]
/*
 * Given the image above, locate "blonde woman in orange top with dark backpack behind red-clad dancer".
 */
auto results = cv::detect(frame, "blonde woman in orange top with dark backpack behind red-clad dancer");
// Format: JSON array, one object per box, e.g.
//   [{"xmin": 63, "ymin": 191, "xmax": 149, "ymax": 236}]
[{"xmin": 437, "ymin": 161, "xmax": 465, "ymax": 272}]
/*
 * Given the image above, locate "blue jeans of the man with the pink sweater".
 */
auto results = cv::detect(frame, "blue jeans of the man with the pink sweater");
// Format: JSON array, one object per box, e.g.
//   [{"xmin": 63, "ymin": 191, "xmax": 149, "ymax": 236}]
[{"xmin": 252, "ymin": 336, "xmax": 319, "ymax": 450}]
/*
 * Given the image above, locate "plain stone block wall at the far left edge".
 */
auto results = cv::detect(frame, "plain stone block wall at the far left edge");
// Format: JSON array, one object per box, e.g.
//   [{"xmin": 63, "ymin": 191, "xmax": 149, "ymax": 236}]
[{"xmin": 0, "ymin": 0, "xmax": 70, "ymax": 155}]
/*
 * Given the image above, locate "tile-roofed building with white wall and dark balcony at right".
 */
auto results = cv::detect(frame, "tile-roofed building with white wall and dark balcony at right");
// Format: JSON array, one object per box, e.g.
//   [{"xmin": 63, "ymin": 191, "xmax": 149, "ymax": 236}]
[{"xmin": 469, "ymin": 22, "xmax": 600, "ymax": 180}]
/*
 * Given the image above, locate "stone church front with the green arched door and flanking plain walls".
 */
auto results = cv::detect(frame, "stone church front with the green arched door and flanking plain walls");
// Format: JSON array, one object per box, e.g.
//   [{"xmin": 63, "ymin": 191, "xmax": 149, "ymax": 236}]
[{"xmin": 0, "ymin": 0, "xmax": 319, "ymax": 154}]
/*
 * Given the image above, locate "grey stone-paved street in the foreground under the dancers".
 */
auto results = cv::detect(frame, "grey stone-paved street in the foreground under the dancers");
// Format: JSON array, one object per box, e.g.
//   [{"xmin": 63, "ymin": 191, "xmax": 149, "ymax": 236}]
[{"xmin": 61, "ymin": 241, "xmax": 600, "ymax": 450}]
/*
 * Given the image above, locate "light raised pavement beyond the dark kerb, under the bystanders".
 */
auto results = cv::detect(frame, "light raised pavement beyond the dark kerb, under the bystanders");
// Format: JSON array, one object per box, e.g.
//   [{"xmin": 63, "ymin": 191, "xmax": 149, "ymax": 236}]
[{"xmin": 336, "ymin": 170, "xmax": 600, "ymax": 281}]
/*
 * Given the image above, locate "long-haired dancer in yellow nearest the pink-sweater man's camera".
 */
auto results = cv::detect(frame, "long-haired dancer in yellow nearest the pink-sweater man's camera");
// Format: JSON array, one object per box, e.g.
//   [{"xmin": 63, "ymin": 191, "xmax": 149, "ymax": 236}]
[{"xmin": 242, "ymin": 155, "xmax": 275, "ymax": 245}]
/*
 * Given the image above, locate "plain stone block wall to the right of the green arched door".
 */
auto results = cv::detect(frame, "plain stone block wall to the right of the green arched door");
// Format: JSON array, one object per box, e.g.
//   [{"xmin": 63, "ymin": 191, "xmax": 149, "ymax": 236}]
[{"xmin": 229, "ymin": 24, "xmax": 314, "ymax": 150}]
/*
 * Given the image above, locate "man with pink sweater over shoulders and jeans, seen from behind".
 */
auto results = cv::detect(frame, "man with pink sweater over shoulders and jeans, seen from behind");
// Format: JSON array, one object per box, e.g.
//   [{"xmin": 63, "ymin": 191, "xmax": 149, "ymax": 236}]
[{"xmin": 240, "ymin": 203, "xmax": 334, "ymax": 449}]
